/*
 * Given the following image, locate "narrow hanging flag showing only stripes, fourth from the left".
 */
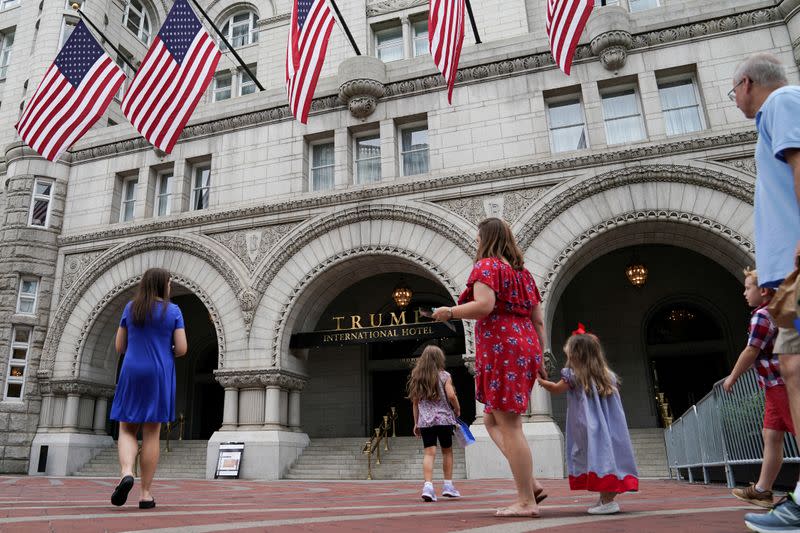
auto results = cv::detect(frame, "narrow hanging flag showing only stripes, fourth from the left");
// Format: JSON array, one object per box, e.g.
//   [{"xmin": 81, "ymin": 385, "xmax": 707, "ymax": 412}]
[{"xmin": 428, "ymin": 0, "xmax": 465, "ymax": 103}]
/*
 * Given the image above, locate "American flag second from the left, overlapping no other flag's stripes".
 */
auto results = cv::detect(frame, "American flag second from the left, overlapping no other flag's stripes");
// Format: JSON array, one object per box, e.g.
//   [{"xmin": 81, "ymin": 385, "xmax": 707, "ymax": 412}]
[{"xmin": 122, "ymin": 0, "xmax": 222, "ymax": 153}]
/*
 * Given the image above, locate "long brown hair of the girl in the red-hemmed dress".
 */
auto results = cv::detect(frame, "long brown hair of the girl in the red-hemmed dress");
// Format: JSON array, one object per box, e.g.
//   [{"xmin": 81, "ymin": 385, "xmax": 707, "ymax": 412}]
[{"xmin": 564, "ymin": 333, "xmax": 619, "ymax": 396}]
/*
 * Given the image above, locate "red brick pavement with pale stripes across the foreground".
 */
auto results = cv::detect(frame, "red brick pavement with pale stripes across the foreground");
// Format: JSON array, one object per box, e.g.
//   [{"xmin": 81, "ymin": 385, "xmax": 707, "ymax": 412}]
[{"xmin": 0, "ymin": 476, "xmax": 758, "ymax": 533}]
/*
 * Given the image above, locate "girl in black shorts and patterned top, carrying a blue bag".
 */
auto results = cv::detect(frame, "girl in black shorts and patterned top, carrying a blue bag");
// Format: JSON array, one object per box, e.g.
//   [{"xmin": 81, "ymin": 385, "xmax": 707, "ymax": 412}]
[{"xmin": 408, "ymin": 345, "xmax": 461, "ymax": 502}]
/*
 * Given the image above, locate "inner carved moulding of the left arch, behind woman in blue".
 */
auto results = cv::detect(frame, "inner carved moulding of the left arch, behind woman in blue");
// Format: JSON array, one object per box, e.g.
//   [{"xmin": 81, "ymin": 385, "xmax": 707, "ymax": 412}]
[{"xmin": 73, "ymin": 274, "xmax": 226, "ymax": 385}]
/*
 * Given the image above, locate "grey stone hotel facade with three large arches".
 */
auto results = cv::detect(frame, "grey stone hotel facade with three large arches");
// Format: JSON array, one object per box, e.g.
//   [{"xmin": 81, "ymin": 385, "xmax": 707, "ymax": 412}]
[{"xmin": 0, "ymin": 0, "xmax": 800, "ymax": 478}]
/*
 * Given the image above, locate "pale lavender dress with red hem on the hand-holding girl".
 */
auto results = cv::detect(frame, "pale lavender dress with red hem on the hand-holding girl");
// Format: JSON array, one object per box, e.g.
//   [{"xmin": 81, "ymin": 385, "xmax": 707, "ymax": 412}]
[{"xmin": 561, "ymin": 368, "xmax": 639, "ymax": 492}]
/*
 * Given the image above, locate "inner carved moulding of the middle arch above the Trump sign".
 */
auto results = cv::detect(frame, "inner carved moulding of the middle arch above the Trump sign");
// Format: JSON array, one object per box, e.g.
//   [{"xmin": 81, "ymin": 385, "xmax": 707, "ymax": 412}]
[{"xmin": 272, "ymin": 245, "xmax": 466, "ymax": 366}]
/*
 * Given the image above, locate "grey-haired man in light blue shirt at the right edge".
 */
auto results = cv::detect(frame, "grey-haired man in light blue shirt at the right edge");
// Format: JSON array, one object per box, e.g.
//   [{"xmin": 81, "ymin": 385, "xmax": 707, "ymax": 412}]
[{"xmin": 728, "ymin": 54, "xmax": 800, "ymax": 532}]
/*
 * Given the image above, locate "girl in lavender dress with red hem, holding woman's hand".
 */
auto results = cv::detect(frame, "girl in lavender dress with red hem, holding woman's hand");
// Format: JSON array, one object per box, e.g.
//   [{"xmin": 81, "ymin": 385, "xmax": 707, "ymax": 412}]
[{"xmin": 539, "ymin": 325, "xmax": 639, "ymax": 514}]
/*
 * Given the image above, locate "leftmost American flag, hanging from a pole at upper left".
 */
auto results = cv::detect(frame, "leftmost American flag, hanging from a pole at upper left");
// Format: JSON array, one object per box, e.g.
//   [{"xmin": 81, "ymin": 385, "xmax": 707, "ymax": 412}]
[{"xmin": 15, "ymin": 21, "xmax": 125, "ymax": 161}]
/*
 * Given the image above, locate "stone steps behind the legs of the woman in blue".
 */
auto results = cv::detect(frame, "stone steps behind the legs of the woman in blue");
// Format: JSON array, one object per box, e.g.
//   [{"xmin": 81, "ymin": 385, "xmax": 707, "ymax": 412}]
[{"xmin": 75, "ymin": 440, "xmax": 208, "ymax": 479}]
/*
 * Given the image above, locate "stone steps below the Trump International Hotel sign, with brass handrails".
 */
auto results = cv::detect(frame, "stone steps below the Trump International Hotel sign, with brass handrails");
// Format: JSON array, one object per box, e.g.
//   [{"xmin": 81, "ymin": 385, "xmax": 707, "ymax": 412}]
[{"xmin": 286, "ymin": 437, "xmax": 467, "ymax": 480}]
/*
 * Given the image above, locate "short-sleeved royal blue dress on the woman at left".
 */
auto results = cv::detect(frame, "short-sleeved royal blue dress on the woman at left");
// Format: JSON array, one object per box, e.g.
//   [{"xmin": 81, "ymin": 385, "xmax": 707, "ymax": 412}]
[{"xmin": 111, "ymin": 302, "xmax": 184, "ymax": 424}]
